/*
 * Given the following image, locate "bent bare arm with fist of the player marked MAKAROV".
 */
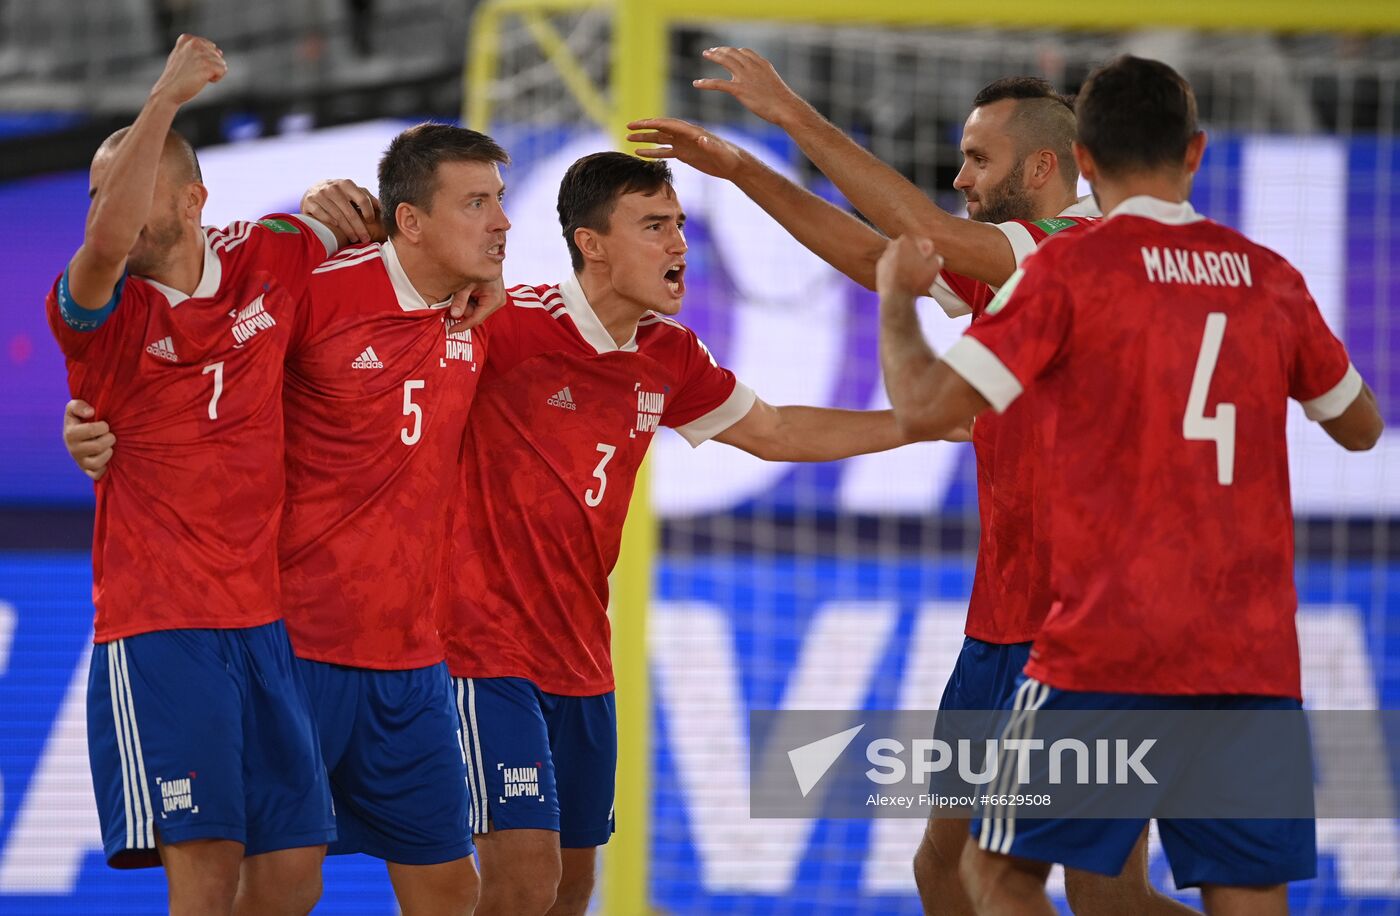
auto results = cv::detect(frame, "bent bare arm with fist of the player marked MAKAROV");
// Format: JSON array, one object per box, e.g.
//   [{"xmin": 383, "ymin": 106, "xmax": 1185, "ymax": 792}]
[{"xmin": 878, "ymin": 237, "xmax": 990, "ymax": 441}]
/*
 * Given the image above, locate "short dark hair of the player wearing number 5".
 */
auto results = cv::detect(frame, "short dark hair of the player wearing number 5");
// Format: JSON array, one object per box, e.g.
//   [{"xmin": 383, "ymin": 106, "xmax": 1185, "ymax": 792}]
[{"xmin": 379, "ymin": 122, "xmax": 511, "ymax": 238}]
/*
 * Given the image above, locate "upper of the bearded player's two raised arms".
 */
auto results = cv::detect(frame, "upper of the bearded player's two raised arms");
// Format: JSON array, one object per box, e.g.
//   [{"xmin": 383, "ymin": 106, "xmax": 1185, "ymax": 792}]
[{"xmin": 694, "ymin": 48, "xmax": 1016, "ymax": 286}]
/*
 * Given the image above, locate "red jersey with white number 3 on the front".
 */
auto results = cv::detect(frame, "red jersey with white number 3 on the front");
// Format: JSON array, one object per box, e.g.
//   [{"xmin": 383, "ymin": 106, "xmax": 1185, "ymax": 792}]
[{"xmin": 441, "ymin": 279, "xmax": 755, "ymax": 696}]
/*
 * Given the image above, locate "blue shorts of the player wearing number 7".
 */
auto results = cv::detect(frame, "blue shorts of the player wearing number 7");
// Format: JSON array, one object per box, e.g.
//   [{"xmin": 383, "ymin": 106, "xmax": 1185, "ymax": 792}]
[{"xmin": 87, "ymin": 620, "xmax": 336, "ymax": 868}]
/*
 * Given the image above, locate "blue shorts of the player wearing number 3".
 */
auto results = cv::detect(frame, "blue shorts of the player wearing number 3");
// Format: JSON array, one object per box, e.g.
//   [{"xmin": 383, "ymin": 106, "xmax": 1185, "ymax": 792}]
[{"xmin": 452, "ymin": 678, "xmax": 617, "ymax": 849}]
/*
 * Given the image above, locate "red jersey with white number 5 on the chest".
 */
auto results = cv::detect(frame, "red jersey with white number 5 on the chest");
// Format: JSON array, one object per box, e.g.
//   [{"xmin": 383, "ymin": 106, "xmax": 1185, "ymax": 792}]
[{"xmin": 281, "ymin": 242, "xmax": 483, "ymax": 669}]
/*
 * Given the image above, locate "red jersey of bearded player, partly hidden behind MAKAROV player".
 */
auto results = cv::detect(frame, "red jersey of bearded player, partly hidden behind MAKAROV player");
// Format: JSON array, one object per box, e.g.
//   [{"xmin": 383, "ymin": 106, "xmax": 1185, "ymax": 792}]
[{"xmin": 930, "ymin": 200, "xmax": 1098, "ymax": 644}]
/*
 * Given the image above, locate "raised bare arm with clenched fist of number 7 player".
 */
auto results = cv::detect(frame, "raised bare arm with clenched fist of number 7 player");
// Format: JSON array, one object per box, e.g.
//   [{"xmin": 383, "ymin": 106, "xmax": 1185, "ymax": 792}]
[{"xmin": 67, "ymin": 35, "xmax": 227, "ymax": 311}]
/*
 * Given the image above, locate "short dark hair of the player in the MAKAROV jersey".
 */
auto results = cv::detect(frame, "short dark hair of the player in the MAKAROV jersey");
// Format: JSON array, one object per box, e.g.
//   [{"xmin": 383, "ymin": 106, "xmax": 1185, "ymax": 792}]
[{"xmin": 1075, "ymin": 55, "xmax": 1197, "ymax": 176}]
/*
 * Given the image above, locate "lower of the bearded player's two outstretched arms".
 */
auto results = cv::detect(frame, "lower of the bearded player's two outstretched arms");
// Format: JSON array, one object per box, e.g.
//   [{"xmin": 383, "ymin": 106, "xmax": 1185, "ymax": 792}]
[{"xmin": 627, "ymin": 118, "xmax": 886, "ymax": 290}]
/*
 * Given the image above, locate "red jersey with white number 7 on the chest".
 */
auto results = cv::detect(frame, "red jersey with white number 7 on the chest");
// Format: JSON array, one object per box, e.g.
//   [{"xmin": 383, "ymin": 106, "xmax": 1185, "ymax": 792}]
[{"xmin": 46, "ymin": 214, "xmax": 335, "ymax": 643}]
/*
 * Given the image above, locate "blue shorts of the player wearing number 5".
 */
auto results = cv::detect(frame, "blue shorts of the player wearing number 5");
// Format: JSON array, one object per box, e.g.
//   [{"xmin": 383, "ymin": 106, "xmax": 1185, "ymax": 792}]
[{"xmin": 297, "ymin": 658, "xmax": 472, "ymax": 866}]
